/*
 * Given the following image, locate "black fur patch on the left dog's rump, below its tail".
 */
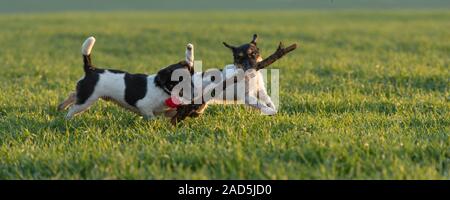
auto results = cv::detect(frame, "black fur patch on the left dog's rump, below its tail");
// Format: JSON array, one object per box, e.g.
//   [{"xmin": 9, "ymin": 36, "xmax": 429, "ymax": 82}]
[{"xmin": 76, "ymin": 73, "xmax": 100, "ymax": 105}]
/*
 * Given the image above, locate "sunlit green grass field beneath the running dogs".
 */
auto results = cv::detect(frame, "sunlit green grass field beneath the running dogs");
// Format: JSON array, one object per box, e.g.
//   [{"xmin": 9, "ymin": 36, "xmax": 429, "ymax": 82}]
[{"xmin": 0, "ymin": 11, "xmax": 450, "ymax": 179}]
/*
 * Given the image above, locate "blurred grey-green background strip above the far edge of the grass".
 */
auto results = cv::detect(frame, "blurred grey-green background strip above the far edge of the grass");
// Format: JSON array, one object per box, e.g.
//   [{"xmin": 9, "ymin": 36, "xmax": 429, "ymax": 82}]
[{"xmin": 0, "ymin": 0, "xmax": 450, "ymax": 12}]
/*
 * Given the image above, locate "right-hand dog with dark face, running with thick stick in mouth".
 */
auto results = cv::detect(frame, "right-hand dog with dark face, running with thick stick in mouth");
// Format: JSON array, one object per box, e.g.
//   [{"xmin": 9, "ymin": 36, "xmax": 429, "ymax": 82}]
[{"xmin": 171, "ymin": 34, "xmax": 297, "ymax": 125}]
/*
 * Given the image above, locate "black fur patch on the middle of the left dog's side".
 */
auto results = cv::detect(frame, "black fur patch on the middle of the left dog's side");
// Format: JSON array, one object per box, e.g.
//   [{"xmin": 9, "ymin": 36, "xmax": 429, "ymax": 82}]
[{"xmin": 125, "ymin": 73, "xmax": 147, "ymax": 107}]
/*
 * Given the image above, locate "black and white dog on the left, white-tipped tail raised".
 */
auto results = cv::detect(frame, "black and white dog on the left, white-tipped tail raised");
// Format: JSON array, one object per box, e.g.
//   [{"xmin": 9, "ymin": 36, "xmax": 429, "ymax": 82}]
[{"xmin": 58, "ymin": 37, "xmax": 194, "ymax": 119}]
